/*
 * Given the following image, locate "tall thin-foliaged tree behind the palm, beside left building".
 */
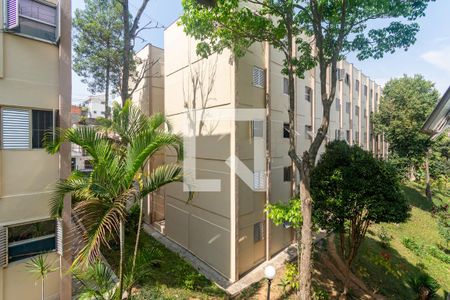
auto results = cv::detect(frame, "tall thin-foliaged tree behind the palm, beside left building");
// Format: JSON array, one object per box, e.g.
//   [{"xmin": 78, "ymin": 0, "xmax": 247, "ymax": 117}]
[{"xmin": 73, "ymin": 0, "xmax": 123, "ymax": 118}]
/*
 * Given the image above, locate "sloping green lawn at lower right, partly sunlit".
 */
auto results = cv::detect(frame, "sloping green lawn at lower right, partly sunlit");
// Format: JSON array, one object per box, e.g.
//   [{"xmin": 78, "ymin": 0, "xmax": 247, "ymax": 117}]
[{"xmin": 354, "ymin": 184, "xmax": 450, "ymax": 299}]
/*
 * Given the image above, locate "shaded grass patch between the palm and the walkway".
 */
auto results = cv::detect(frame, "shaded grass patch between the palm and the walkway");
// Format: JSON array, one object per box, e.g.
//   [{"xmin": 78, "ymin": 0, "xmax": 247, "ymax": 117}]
[{"xmin": 103, "ymin": 231, "xmax": 225, "ymax": 300}]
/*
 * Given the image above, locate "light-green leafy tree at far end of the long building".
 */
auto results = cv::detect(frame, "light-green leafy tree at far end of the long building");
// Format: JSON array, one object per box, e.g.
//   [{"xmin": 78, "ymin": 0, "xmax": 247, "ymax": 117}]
[{"xmin": 373, "ymin": 75, "xmax": 439, "ymax": 199}]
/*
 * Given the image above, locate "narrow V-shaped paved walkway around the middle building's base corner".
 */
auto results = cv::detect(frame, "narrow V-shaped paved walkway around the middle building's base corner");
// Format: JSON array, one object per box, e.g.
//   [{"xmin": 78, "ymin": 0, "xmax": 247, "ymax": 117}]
[{"xmin": 144, "ymin": 224, "xmax": 297, "ymax": 297}]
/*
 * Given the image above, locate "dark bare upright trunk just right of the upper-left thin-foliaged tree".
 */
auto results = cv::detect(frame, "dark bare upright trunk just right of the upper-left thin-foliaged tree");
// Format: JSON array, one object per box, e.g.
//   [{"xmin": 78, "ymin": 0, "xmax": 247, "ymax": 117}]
[{"xmin": 121, "ymin": 0, "xmax": 131, "ymax": 105}]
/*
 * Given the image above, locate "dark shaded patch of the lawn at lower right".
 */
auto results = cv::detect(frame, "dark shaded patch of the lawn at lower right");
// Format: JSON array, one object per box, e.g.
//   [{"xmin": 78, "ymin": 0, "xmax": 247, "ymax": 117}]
[{"xmin": 353, "ymin": 236, "xmax": 444, "ymax": 299}]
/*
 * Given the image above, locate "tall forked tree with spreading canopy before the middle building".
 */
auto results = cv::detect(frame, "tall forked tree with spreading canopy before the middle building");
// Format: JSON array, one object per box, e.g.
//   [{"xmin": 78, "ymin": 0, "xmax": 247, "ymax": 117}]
[{"xmin": 181, "ymin": 0, "xmax": 429, "ymax": 299}]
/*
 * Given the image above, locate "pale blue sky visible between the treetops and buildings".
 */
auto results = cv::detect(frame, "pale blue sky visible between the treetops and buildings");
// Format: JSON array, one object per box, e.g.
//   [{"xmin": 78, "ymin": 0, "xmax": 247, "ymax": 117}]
[{"xmin": 72, "ymin": 0, "xmax": 450, "ymax": 103}]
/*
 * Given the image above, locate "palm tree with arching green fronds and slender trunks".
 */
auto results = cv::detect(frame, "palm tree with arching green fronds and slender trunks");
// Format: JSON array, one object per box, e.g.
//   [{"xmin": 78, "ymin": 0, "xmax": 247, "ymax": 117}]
[{"xmin": 47, "ymin": 101, "xmax": 183, "ymax": 295}]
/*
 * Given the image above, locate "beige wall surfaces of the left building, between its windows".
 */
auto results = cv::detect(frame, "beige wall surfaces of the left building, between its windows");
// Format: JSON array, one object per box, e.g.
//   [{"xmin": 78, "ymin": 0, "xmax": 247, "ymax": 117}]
[{"xmin": 0, "ymin": 0, "xmax": 63, "ymax": 300}]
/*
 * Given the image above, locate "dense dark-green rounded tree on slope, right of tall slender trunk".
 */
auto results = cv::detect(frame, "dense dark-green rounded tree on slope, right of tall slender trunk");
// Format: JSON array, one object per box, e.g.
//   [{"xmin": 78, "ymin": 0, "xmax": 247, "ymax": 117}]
[{"xmin": 311, "ymin": 141, "xmax": 409, "ymax": 274}]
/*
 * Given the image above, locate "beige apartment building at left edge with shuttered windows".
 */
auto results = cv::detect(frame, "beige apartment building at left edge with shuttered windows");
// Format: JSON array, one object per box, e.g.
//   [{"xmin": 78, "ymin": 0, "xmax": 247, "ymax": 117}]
[{"xmin": 0, "ymin": 0, "xmax": 71, "ymax": 300}]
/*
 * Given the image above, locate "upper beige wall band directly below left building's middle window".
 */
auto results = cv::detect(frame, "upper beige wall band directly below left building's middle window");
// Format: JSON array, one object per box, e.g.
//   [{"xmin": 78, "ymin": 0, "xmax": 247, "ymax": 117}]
[{"xmin": 0, "ymin": 149, "xmax": 59, "ymax": 196}]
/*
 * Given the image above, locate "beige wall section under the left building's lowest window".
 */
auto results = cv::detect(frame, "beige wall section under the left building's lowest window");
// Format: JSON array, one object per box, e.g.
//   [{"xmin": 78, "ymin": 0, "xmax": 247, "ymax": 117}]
[{"xmin": 0, "ymin": 253, "xmax": 59, "ymax": 300}]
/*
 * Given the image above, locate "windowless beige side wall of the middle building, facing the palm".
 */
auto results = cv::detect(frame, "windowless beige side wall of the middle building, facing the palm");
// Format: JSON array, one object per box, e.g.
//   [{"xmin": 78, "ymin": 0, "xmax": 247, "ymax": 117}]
[{"xmin": 164, "ymin": 25, "xmax": 235, "ymax": 278}]
